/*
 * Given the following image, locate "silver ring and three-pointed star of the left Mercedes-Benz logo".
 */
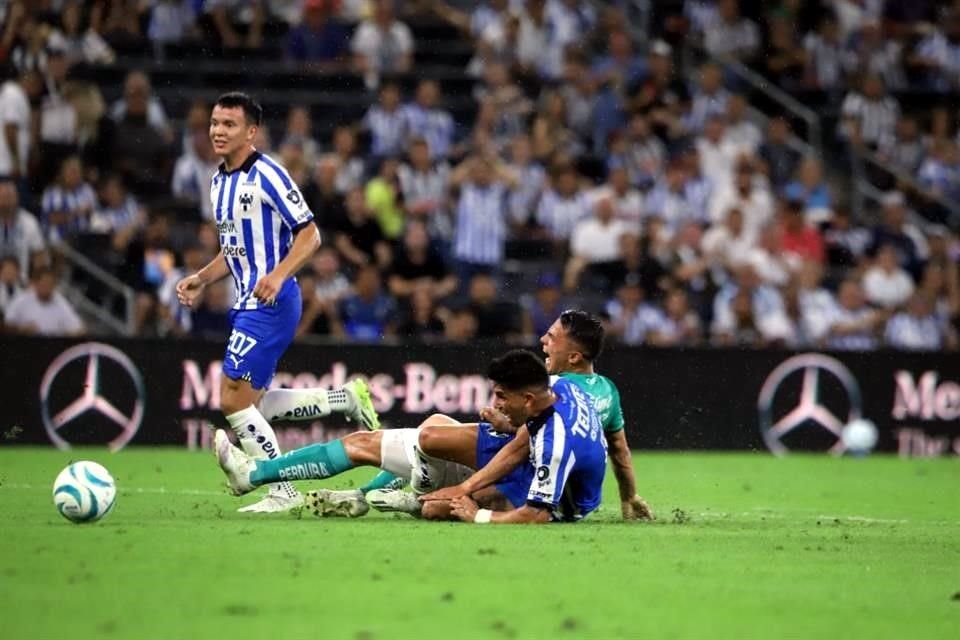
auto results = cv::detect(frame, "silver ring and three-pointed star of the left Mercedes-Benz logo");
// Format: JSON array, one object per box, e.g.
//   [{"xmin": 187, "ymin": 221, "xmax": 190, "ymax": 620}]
[{"xmin": 40, "ymin": 342, "xmax": 146, "ymax": 451}]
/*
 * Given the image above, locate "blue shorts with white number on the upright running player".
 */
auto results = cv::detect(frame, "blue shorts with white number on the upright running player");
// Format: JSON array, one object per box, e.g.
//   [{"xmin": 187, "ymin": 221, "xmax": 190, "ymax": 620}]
[{"xmin": 223, "ymin": 280, "xmax": 303, "ymax": 389}]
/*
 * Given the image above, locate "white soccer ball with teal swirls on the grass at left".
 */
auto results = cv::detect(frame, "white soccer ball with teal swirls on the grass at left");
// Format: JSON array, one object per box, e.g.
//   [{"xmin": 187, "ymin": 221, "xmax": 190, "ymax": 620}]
[{"xmin": 53, "ymin": 460, "xmax": 117, "ymax": 523}]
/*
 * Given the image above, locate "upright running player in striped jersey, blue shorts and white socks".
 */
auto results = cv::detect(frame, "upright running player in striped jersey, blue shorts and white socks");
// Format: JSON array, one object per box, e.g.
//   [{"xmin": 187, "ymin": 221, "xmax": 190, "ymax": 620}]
[{"xmin": 177, "ymin": 93, "xmax": 379, "ymax": 512}]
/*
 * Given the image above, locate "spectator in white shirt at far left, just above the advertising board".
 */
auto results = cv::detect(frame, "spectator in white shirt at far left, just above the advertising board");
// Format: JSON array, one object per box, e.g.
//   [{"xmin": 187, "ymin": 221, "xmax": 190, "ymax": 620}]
[{"xmin": 4, "ymin": 268, "xmax": 86, "ymax": 336}]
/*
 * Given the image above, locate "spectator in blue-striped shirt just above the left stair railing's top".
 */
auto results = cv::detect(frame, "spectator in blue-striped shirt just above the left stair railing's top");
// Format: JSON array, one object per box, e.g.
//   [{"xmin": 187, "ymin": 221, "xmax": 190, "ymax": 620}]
[{"xmin": 42, "ymin": 156, "xmax": 98, "ymax": 243}]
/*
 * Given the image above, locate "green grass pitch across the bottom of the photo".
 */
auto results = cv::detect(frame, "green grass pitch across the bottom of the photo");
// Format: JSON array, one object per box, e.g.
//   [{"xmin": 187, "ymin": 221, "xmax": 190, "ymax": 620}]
[{"xmin": 0, "ymin": 449, "xmax": 960, "ymax": 640}]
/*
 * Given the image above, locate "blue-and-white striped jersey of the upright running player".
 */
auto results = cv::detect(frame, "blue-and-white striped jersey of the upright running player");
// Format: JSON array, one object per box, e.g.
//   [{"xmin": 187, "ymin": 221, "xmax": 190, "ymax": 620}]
[{"xmin": 210, "ymin": 151, "xmax": 313, "ymax": 309}]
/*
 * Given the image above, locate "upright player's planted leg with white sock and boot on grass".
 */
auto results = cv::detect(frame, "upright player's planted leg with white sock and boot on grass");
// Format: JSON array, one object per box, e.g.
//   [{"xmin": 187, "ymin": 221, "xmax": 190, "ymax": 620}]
[{"xmin": 220, "ymin": 376, "xmax": 303, "ymax": 513}]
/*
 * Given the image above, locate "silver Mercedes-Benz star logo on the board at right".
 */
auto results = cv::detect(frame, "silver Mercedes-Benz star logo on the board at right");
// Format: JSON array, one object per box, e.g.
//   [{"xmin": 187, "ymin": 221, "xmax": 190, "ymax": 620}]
[{"xmin": 757, "ymin": 353, "xmax": 862, "ymax": 455}]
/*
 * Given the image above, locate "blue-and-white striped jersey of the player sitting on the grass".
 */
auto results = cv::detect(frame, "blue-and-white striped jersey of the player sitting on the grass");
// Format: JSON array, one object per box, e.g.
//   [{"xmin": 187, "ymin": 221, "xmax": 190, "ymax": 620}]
[{"xmin": 527, "ymin": 378, "xmax": 607, "ymax": 521}]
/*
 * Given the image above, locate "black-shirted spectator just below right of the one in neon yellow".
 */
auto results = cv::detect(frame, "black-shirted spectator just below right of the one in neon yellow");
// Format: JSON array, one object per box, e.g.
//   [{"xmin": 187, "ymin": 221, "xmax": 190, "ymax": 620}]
[{"xmin": 387, "ymin": 220, "xmax": 457, "ymax": 301}]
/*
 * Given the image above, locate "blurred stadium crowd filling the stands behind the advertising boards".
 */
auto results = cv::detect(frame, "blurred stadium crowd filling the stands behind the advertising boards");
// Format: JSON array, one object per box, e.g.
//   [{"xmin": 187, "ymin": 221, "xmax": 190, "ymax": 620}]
[{"xmin": 0, "ymin": 0, "xmax": 960, "ymax": 350}]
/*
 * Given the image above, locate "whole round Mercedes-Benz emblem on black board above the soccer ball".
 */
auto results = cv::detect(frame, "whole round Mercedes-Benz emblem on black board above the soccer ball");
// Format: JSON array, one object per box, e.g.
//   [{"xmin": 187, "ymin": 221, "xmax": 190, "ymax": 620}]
[{"xmin": 40, "ymin": 342, "xmax": 146, "ymax": 451}]
